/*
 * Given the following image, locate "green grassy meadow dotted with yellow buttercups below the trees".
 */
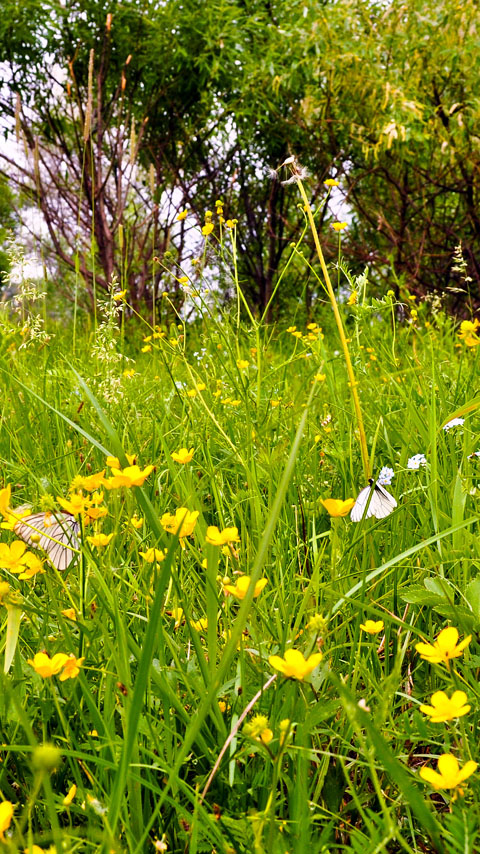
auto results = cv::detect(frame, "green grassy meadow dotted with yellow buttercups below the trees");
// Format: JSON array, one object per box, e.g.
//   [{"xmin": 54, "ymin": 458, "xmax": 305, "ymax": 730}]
[{"xmin": 0, "ymin": 202, "xmax": 480, "ymax": 854}]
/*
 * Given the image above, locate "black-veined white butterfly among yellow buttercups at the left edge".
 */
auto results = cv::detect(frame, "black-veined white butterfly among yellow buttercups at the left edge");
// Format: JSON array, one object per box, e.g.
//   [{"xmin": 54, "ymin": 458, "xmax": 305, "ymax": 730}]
[{"xmin": 14, "ymin": 508, "xmax": 80, "ymax": 571}]
